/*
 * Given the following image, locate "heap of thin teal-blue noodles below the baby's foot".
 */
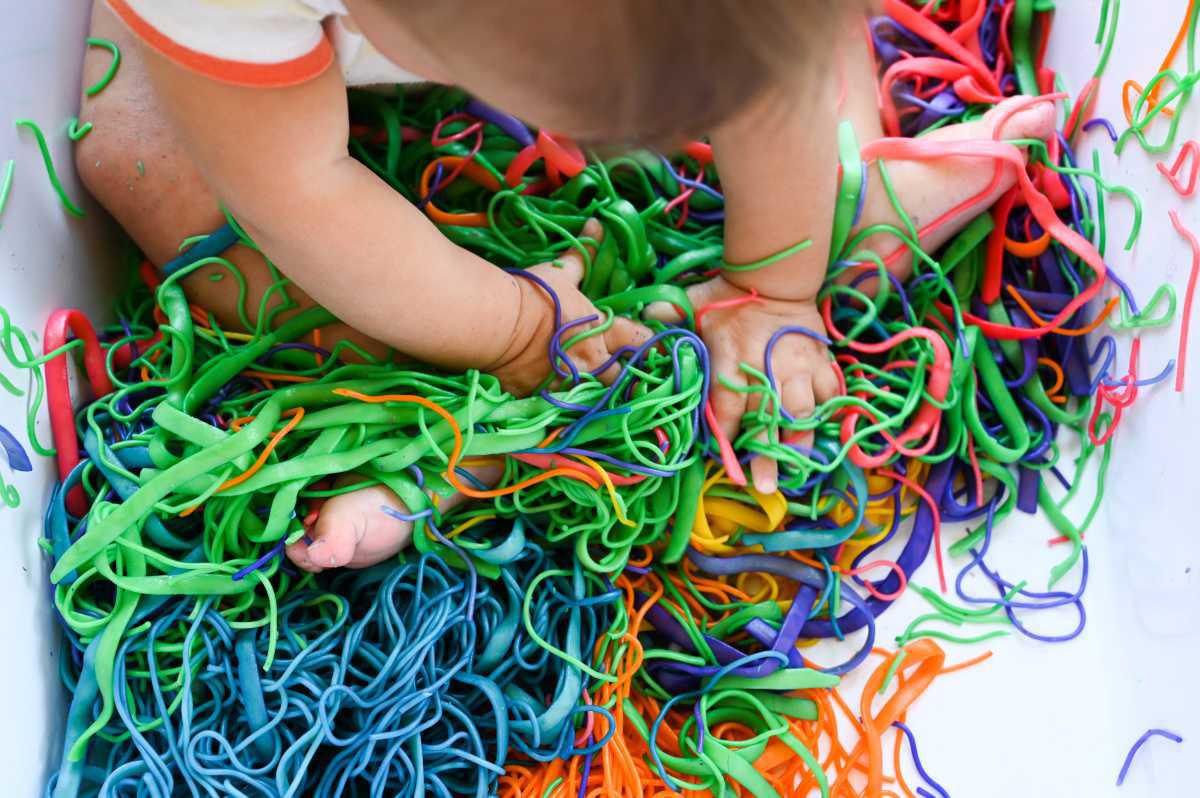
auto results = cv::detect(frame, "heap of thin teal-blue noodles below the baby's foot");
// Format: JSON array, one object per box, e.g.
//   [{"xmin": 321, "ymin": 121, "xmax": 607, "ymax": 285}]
[{"xmin": 46, "ymin": 539, "xmax": 618, "ymax": 798}]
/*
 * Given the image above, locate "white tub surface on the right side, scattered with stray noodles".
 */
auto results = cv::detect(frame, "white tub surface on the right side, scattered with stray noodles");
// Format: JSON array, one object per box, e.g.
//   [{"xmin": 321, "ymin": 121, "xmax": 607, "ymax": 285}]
[{"xmin": 825, "ymin": 0, "xmax": 1200, "ymax": 798}]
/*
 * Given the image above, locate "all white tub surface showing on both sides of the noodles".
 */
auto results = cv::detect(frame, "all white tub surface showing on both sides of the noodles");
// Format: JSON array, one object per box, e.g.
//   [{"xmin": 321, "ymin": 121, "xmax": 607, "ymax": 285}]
[{"xmin": 0, "ymin": 0, "xmax": 1200, "ymax": 798}]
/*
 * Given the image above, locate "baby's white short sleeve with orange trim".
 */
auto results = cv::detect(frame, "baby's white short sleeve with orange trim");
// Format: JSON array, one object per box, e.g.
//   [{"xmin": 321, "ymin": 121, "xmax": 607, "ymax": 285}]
[{"xmin": 108, "ymin": 0, "xmax": 334, "ymax": 88}]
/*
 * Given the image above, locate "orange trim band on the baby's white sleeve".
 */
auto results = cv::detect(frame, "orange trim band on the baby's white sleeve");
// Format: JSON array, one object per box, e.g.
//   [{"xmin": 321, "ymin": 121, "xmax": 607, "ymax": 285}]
[{"xmin": 108, "ymin": 0, "xmax": 334, "ymax": 89}]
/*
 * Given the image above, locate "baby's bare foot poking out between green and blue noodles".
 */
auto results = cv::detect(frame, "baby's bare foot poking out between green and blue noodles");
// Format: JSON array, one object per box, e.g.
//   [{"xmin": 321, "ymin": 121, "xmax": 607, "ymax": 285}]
[{"xmin": 287, "ymin": 469, "xmax": 499, "ymax": 574}]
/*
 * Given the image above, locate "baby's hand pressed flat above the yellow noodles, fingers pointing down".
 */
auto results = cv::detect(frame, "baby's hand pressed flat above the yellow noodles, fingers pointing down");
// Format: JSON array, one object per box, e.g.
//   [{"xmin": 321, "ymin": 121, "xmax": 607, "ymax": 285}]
[{"xmin": 647, "ymin": 277, "xmax": 839, "ymax": 493}]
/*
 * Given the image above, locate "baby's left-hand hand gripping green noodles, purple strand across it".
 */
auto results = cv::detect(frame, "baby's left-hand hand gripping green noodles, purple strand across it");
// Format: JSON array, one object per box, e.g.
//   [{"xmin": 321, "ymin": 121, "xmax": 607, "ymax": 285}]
[{"xmin": 486, "ymin": 220, "xmax": 650, "ymax": 396}]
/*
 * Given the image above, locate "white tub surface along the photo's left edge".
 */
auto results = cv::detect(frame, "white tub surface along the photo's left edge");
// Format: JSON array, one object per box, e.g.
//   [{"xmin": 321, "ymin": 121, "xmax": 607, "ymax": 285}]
[{"xmin": 0, "ymin": 0, "xmax": 118, "ymax": 798}]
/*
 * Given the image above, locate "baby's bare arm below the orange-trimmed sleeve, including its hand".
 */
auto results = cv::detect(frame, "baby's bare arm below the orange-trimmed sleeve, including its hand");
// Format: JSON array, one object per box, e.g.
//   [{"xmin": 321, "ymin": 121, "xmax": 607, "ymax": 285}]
[{"xmin": 146, "ymin": 52, "xmax": 642, "ymax": 391}]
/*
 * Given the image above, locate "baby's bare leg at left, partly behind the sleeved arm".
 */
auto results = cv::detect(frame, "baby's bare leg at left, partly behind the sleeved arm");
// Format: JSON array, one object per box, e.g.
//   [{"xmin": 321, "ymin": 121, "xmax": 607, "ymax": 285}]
[{"xmin": 76, "ymin": 1, "xmax": 386, "ymax": 356}]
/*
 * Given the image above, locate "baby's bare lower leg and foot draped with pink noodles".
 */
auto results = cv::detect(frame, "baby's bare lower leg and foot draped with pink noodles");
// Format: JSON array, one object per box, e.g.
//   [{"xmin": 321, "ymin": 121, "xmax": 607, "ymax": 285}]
[{"xmin": 847, "ymin": 97, "xmax": 1055, "ymax": 279}]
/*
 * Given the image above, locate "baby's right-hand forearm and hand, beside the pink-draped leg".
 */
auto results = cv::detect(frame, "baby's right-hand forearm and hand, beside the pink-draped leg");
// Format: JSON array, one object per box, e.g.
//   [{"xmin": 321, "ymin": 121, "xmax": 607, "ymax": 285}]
[{"xmin": 655, "ymin": 20, "xmax": 881, "ymax": 493}]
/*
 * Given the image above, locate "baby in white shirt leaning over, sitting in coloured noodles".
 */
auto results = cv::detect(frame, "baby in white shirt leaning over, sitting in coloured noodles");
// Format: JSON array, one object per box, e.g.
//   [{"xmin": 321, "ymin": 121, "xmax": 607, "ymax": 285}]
[{"xmin": 77, "ymin": 0, "xmax": 1055, "ymax": 572}]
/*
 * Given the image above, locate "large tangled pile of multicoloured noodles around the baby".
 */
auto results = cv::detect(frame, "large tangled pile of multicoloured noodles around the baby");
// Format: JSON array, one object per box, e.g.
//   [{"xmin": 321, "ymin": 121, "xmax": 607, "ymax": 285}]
[{"xmin": 16, "ymin": 0, "xmax": 1195, "ymax": 798}]
